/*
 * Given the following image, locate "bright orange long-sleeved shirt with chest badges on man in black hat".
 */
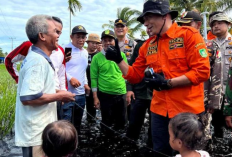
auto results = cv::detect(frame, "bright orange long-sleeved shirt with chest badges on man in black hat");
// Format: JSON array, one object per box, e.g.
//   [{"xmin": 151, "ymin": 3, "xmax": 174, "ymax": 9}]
[{"xmin": 124, "ymin": 23, "xmax": 210, "ymax": 118}]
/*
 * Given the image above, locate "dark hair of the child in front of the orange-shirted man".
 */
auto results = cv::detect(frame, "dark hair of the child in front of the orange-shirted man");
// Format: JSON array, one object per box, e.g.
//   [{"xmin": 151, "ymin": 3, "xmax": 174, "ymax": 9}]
[{"xmin": 169, "ymin": 112, "xmax": 204, "ymax": 150}]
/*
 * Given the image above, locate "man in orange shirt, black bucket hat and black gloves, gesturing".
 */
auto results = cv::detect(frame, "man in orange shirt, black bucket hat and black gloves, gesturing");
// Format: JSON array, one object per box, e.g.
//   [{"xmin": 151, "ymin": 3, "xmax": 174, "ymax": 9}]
[{"xmin": 106, "ymin": 0, "xmax": 210, "ymax": 157}]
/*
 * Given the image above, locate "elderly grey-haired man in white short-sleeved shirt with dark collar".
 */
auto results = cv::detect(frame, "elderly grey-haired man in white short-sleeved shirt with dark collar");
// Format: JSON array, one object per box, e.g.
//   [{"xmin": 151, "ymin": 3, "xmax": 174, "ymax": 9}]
[{"xmin": 15, "ymin": 15, "xmax": 75, "ymax": 157}]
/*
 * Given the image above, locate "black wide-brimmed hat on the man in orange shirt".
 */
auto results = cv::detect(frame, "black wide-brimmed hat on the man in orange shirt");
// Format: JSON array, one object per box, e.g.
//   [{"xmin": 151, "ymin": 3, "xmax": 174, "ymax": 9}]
[{"xmin": 137, "ymin": 0, "xmax": 178, "ymax": 23}]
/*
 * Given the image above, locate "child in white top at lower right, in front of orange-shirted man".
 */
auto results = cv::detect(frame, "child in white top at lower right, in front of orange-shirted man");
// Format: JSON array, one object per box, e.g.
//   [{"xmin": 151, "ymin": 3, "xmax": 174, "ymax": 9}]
[{"xmin": 169, "ymin": 113, "xmax": 209, "ymax": 157}]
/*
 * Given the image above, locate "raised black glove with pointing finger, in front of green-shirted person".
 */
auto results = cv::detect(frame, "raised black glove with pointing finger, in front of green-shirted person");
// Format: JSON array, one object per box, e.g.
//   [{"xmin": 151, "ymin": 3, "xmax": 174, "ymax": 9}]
[{"xmin": 106, "ymin": 39, "xmax": 123, "ymax": 64}]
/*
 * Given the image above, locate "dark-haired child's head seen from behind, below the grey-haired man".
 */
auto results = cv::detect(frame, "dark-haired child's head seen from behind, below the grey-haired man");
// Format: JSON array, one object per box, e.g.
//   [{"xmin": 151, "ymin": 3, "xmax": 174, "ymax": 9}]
[{"xmin": 42, "ymin": 120, "xmax": 78, "ymax": 157}]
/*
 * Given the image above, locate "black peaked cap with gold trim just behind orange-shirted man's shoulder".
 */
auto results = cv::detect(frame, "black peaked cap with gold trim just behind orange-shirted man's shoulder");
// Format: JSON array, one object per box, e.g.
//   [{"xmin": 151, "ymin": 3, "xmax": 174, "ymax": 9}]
[{"xmin": 177, "ymin": 11, "xmax": 202, "ymax": 24}]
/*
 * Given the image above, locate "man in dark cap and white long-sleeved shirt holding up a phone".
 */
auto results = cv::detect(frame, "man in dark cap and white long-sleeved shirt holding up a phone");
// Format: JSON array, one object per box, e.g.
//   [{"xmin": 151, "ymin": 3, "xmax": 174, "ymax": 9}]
[{"xmin": 62, "ymin": 25, "xmax": 90, "ymax": 133}]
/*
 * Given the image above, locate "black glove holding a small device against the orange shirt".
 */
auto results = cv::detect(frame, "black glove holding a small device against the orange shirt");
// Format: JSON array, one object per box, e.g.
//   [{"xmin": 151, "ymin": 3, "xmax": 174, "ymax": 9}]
[{"xmin": 144, "ymin": 73, "xmax": 171, "ymax": 91}]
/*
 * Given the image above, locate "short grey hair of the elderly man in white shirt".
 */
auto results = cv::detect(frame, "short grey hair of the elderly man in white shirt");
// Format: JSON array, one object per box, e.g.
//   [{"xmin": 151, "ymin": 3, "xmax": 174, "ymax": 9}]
[{"xmin": 26, "ymin": 15, "xmax": 53, "ymax": 44}]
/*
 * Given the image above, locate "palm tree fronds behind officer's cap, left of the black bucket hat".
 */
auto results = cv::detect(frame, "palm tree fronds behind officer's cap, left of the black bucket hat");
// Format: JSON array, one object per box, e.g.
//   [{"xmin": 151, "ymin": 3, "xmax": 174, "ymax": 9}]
[{"xmin": 102, "ymin": 7, "xmax": 142, "ymax": 38}]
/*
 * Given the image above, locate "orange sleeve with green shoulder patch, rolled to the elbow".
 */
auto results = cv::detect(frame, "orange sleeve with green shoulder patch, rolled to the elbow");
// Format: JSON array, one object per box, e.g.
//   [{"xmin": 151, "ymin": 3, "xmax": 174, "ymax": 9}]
[{"xmin": 185, "ymin": 32, "xmax": 210, "ymax": 85}]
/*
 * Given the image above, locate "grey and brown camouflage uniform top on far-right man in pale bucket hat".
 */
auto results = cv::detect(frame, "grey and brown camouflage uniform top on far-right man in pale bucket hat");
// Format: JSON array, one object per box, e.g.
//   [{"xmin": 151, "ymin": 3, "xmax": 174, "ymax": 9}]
[{"xmin": 205, "ymin": 34, "xmax": 232, "ymax": 109}]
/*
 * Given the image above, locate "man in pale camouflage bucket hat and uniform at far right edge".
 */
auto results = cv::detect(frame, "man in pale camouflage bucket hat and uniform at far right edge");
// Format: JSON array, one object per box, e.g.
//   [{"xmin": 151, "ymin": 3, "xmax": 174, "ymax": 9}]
[{"xmin": 208, "ymin": 12, "xmax": 232, "ymax": 137}]
